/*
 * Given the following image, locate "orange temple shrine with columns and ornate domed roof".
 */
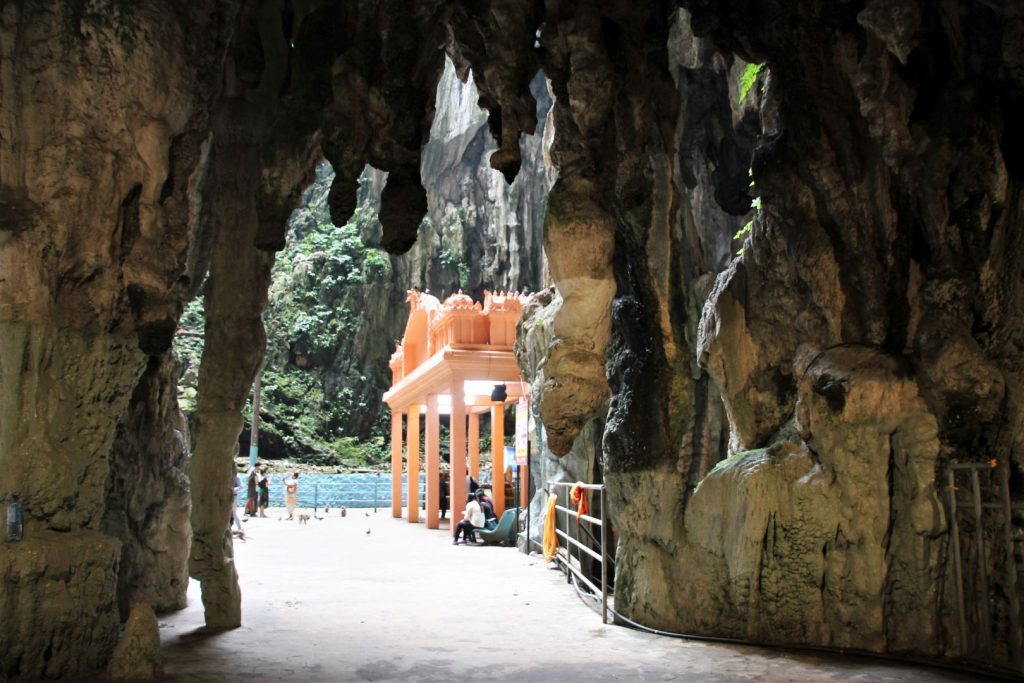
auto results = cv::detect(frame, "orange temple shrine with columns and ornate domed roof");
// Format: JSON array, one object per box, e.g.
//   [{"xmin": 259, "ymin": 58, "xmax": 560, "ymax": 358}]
[{"xmin": 383, "ymin": 290, "xmax": 529, "ymax": 528}]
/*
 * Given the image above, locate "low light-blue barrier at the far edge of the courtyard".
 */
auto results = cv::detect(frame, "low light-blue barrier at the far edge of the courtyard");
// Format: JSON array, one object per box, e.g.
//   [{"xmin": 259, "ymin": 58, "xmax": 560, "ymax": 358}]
[{"xmin": 264, "ymin": 472, "xmax": 426, "ymax": 508}]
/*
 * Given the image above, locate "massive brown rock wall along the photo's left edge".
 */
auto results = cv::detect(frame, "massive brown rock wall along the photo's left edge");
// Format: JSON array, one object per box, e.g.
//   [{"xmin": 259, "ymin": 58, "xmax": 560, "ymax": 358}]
[{"xmin": 0, "ymin": 2, "xmax": 234, "ymax": 679}]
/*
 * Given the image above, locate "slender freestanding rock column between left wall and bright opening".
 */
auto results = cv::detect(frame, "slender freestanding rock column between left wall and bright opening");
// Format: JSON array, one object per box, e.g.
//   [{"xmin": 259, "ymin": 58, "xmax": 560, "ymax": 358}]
[{"xmin": 189, "ymin": 139, "xmax": 273, "ymax": 629}]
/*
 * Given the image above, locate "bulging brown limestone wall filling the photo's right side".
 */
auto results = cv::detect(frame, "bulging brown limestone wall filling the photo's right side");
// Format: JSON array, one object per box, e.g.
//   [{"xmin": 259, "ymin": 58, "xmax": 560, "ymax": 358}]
[{"xmin": 684, "ymin": 2, "xmax": 1024, "ymax": 667}]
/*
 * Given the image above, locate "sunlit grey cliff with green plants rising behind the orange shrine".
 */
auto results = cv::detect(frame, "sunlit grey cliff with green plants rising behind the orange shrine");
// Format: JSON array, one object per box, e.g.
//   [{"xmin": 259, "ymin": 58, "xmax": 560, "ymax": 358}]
[{"xmin": 222, "ymin": 60, "xmax": 553, "ymax": 456}]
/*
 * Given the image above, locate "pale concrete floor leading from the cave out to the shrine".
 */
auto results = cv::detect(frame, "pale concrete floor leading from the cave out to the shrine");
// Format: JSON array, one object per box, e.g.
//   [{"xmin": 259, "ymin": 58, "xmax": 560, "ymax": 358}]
[{"xmin": 161, "ymin": 509, "xmax": 978, "ymax": 682}]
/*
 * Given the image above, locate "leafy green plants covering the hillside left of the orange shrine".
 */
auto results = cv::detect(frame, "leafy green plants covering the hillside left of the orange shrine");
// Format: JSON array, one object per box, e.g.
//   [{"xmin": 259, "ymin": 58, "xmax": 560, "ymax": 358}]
[{"xmin": 174, "ymin": 164, "xmax": 395, "ymax": 467}]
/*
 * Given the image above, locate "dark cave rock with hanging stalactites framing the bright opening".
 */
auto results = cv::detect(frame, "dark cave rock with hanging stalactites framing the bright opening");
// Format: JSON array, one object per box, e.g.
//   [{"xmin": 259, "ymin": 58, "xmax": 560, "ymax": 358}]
[{"xmin": 0, "ymin": 0, "xmax": 1024, "ymax": 680}]
